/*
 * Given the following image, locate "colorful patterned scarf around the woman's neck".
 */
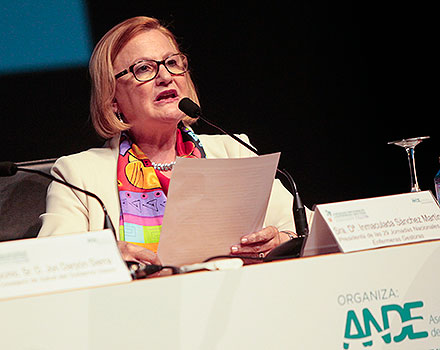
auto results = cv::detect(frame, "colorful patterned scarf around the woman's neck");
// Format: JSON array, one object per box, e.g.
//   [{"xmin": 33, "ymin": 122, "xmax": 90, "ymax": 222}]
[{"xmin": 117, "ymin": 124, "xmax": 206, "ymax": 252}]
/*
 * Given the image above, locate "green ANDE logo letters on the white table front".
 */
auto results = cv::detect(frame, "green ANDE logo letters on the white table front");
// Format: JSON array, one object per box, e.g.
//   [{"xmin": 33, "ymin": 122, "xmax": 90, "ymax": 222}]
[{"xmin": 344, "ymin": 301, "xmax": 428, "ymax": 349}]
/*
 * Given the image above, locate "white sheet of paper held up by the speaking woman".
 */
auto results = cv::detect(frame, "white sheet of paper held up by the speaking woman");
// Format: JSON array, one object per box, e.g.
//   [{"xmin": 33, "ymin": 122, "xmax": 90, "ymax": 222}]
[{"xmin": 158, "ymin": 153, "xmax": 280, "ymax": 266}]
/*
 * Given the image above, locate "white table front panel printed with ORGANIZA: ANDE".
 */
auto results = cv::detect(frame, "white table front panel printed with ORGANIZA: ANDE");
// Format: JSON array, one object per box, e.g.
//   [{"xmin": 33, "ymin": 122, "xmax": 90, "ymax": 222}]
[{"xmin": 0, "ymin": 241, "xmax": 440, "ymax": 350}]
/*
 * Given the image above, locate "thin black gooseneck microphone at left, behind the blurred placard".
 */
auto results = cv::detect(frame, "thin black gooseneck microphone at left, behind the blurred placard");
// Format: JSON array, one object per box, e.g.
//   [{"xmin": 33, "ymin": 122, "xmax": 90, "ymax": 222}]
[{"xmin": 0, "ymin": 162, "xmax": 116, "ymax": 239}]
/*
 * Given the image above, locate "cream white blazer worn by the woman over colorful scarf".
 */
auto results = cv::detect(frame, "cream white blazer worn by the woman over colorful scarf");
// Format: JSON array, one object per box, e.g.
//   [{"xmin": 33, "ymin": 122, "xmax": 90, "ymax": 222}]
[{"xmin": 38, "ymin": 135, "xmax": 300, "ymax": 237}]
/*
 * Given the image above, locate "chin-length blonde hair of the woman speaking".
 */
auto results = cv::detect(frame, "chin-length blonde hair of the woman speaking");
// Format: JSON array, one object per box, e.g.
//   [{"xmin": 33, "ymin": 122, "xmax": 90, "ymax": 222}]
[{"xmin": 89, "ymin": 16, "xmax": 198, "ymax": 139}]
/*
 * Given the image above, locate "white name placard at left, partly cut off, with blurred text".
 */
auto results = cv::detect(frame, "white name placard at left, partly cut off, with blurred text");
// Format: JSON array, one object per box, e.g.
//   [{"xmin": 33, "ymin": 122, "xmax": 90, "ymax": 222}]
[{"xmin": 0, "ymin": 230, "xmax": 131, "ymax": 299}]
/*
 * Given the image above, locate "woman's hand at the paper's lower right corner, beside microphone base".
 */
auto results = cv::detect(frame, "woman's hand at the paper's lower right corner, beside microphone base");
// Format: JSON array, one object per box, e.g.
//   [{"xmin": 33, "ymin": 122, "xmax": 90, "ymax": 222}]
[{"xmin": 231, "ymin": 226, "xmax": 289, "ymax": 258}]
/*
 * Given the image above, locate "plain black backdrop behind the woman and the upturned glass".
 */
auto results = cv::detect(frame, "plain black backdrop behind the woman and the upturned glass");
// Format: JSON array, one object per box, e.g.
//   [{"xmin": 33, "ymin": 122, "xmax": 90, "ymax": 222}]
[{"xmin": 0, "ymin": 0, "xmax": 440, "ymax": 207}]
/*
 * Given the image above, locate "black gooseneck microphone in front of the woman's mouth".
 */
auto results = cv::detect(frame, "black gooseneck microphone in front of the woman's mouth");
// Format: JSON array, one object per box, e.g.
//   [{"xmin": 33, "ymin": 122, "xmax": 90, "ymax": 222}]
[{"xmin": 179, "ymin": 97, "xmax": 309, "ymax": 262}]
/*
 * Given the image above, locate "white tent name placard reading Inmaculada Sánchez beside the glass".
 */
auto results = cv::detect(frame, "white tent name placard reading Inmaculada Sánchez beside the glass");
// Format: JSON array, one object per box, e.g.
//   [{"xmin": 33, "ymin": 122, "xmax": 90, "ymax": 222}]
[{"xmin": 304, "ymin": 191, "xmax": 440, "ymax": 256}]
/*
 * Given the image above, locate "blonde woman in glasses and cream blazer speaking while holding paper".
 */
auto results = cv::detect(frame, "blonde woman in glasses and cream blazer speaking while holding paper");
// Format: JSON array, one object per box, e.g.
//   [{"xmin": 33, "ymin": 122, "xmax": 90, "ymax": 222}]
[{"xmin": 39, "ymin": 17, "xmax": 306, "ymax": 264}]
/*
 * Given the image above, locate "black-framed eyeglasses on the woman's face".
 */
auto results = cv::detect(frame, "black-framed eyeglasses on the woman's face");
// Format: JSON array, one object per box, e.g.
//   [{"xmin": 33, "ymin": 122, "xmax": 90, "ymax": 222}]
[{"xmin": 115, "ymin": 53, "xmax": 188, "ymax": 82}]
